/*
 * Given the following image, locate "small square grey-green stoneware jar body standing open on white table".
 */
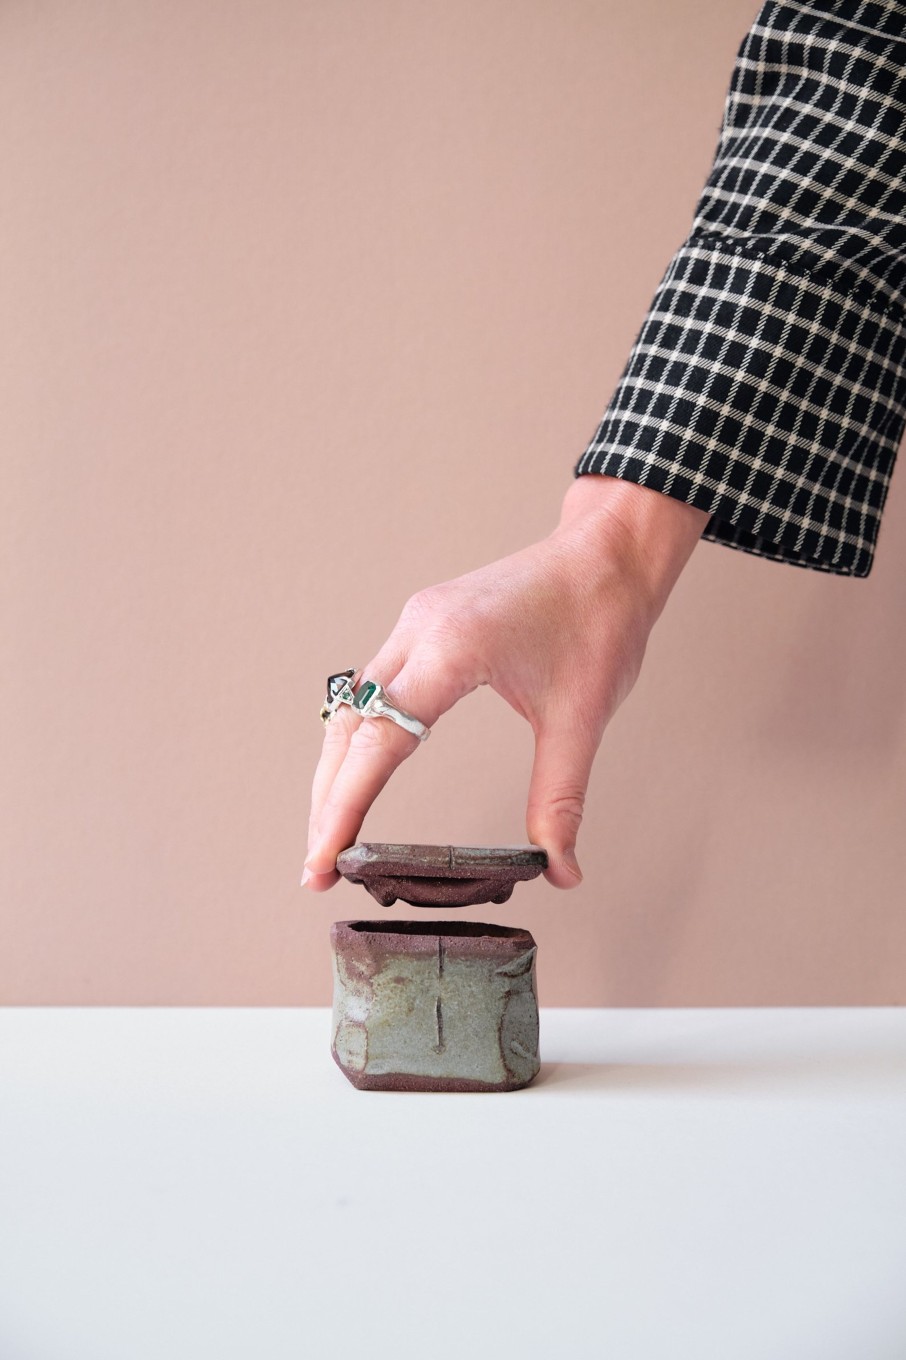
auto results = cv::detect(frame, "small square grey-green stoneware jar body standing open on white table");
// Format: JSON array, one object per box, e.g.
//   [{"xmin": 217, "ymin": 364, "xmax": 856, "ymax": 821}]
[{"xmin": 331, "ymin": 921, "xmax": 540, "ymax": 1091}]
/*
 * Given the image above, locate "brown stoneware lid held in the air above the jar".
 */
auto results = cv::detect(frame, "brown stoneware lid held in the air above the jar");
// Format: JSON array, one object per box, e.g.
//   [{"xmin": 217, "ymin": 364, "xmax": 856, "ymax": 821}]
[{"xmin": 336, "ymin": 842, "xmax": 547, "ymax": 907}]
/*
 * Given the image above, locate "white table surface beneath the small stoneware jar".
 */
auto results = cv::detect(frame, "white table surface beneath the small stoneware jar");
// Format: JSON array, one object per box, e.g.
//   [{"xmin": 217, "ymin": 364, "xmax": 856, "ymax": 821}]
[{"xmin": 0, "ymin": 1009, "xmax": 906, "ymax": 1360}]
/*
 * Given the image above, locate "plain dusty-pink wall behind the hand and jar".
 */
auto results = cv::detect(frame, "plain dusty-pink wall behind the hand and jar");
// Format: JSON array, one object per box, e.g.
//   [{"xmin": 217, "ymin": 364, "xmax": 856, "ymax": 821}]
[{"xmin": 0, "ymin": 0, "xmax": 906, "ymax": 1005}]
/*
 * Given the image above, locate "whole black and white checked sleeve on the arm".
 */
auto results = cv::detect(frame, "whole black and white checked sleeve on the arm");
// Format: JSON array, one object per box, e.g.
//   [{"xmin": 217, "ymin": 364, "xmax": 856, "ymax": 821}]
[{"xmin": 575, "ymin": 0, "xmax": 906, "ymax": 577}]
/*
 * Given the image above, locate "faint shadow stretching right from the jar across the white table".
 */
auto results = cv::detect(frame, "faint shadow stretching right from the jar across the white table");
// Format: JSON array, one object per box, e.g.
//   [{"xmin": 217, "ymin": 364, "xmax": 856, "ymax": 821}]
[{"xmin": 532, "ymin": 1051, "xmax": 906, "ymax": 1095}]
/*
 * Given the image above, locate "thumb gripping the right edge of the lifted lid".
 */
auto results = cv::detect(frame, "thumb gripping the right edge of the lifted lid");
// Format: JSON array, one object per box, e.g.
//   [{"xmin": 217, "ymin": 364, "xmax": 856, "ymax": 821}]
[{"xmin": 525, "ymin": 715, "xmax": 599, "ymax": 888}]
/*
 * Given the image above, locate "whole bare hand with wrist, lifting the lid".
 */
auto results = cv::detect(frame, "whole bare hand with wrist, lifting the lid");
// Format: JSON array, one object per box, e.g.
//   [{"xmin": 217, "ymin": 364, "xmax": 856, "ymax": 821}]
[{"xmin": 302, "ymin": 476, "xmax": 707, "ymax": 892}]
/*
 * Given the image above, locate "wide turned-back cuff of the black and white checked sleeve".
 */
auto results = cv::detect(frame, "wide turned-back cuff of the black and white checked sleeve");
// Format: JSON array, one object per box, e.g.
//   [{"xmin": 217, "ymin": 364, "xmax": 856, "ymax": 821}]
[{"xmin": 575, "ymin": 234, "xmax": 906, "ymax": 577}]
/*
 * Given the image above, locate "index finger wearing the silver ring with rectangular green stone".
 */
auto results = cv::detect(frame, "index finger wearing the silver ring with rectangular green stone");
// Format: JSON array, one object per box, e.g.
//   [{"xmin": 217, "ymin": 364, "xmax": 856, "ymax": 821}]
[{"xmin": 305, "ymin": 656, "xmax": 473, "ymax": 887}]
